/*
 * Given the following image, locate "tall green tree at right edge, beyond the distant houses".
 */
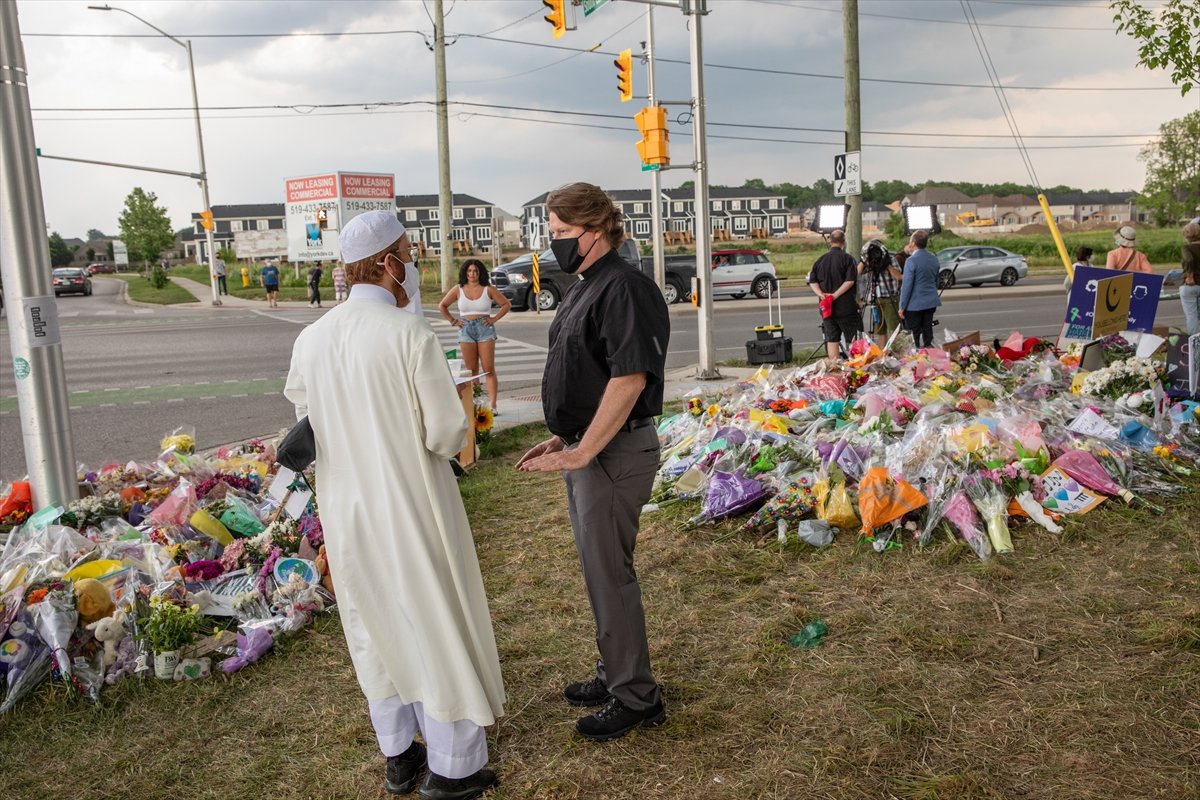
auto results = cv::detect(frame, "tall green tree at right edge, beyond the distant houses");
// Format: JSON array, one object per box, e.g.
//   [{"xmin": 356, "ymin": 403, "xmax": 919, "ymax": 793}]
[{"xmin": 1138, "ymin": 112, "xmax": 1200, "ymax": 225}]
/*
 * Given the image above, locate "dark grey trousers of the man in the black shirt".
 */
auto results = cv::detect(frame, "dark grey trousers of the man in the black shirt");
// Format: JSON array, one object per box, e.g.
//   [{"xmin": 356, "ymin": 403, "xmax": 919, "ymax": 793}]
[{"xmin": 563, "ymin": 426, "xmax": 659, "ymax": 710}]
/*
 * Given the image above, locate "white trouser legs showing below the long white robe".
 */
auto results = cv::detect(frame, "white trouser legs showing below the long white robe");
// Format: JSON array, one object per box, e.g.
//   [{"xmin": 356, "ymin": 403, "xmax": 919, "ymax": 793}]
[{"xmin": 367, "ymin": 696, "xmax": 487, "ymax": 778}]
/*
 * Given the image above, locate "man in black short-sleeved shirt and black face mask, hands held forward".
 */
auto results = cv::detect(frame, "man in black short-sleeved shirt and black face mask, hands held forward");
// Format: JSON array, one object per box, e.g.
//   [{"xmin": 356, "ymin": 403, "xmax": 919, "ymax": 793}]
[{"xmin": 517, "ymin": 184, "xmax": 671, "ymax": 741}]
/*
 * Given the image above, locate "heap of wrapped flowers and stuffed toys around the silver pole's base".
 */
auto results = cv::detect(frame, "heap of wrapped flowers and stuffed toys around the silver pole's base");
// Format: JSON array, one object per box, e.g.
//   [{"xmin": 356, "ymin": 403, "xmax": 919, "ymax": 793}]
[{"xmin": 0, "ymin": 429, "xmax": 335, "ymax": 712}]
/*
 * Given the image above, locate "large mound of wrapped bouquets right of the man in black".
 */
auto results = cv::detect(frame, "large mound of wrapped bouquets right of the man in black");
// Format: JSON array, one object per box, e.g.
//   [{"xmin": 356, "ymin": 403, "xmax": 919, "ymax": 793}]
[{"xmin": 650, "ymin": 333, "xmax": 1200, "ymax": 558}]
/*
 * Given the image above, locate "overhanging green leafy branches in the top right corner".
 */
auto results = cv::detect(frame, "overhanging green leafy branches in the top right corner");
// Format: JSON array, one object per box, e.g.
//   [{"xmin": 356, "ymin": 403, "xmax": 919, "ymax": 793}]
[{"xmin": 1109, "ymin": 0, "xmax": 1200, "ymax": 95}]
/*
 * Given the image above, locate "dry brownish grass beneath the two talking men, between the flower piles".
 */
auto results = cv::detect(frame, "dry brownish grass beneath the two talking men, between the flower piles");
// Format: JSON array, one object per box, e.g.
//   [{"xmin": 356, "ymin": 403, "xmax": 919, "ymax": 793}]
[{"xmin": 0, "ymin": 427, "xmax": 1200, "ymax": 800}]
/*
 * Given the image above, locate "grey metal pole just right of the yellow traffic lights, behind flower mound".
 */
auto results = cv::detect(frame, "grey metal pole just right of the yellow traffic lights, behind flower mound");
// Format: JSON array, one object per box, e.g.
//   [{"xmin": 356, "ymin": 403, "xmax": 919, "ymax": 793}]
[{"xmin": 691, "ymin": 0, "xmax": 721, "ymax": 380}]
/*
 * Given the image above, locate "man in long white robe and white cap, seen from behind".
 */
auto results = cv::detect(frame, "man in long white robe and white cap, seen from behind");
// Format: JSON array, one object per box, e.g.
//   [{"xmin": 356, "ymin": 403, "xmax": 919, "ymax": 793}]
[{"xmin": 283, "ymin": 211, "xmax": 504, "ymax": 800}]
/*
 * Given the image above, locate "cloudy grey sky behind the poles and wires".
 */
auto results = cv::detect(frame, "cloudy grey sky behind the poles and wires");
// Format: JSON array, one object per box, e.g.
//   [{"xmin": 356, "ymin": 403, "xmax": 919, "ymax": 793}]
[{"xmin": 11, "ymin": 0, "xmax": 1200, "ymax": 237}]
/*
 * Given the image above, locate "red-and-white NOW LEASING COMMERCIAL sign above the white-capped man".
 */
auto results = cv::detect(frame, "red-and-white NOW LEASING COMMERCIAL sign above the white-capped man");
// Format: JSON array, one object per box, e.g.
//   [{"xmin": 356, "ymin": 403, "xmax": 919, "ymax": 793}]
[{"xmin": 284, "ymin": 173, "xmax": 396, "ymax": 261}]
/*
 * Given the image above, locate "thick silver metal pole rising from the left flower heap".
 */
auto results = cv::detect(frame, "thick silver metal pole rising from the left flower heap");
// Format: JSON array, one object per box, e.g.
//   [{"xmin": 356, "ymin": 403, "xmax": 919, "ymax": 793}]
[{"xmin": 0, "ymin": 0, "xmax": 79, "ymax": 510}]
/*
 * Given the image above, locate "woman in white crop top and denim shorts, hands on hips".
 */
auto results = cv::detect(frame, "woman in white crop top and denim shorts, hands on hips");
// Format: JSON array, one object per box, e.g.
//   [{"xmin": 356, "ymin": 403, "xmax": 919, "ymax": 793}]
[{"xmin": 438, "ymin": 258, "xmax": 511, "ymax": 414}]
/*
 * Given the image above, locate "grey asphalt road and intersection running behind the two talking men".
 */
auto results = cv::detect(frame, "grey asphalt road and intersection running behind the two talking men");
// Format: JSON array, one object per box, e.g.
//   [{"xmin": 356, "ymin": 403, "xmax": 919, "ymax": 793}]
[{"xmin": 0, "ymin": 279, "xmax": 1182, "ymax": 481}]
